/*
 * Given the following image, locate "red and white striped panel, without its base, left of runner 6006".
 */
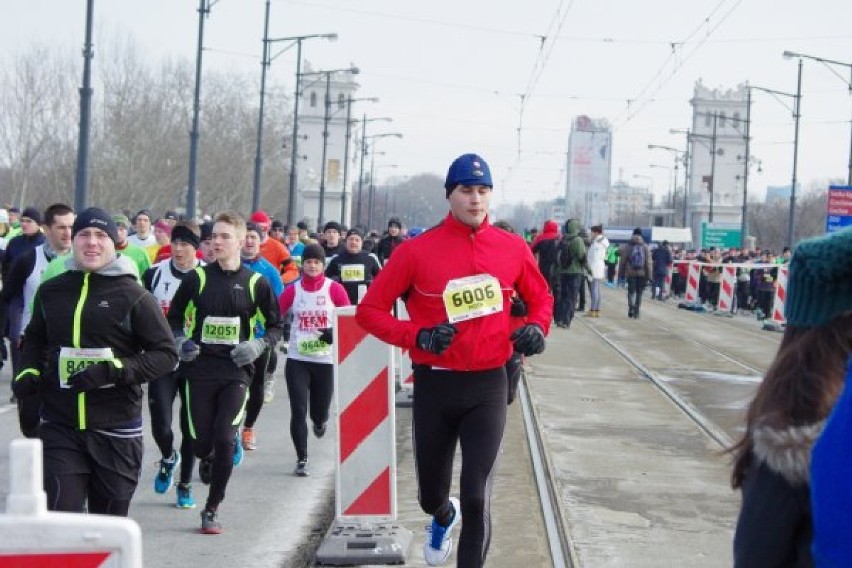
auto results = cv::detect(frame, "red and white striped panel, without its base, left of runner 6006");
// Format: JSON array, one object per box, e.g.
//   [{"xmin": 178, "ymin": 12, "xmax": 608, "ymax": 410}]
[{"xmin": 334, "ymin": 306, "xmax": 396, "ymax": 520}]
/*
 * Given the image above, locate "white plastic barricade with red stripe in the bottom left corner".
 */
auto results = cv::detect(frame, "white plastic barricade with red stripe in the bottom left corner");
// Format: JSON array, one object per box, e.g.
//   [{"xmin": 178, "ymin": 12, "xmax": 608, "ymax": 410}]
[{"xmin": 0, "ymin": 439, "xmax": 142, "ymax": 568}]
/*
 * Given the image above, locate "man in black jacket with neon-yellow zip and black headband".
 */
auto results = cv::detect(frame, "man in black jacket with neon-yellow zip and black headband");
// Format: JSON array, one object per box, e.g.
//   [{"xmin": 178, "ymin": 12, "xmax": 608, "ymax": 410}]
[{"xmin": 13, "ymin": 208, "xmax": 177, "ymax": 516}]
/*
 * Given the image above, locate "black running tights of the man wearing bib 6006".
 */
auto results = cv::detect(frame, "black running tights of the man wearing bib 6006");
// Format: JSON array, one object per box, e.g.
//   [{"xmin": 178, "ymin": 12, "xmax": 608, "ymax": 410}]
[{"xmin": 412, "ymin": 365, "xmax": 507, "ymax": 568}]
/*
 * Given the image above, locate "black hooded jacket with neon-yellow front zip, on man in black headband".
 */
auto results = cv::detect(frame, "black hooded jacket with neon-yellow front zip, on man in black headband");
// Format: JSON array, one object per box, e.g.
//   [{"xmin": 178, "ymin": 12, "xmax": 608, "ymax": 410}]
[{"xmin": 15, "ymin": 255, "xmax": 178, "ymax": 430}]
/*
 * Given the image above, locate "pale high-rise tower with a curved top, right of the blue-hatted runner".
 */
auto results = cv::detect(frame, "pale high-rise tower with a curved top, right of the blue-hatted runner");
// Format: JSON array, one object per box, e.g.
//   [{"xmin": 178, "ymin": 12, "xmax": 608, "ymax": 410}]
[{"xmin": 565, "ymin": 116, "xmax": 612, "ymax": 226}]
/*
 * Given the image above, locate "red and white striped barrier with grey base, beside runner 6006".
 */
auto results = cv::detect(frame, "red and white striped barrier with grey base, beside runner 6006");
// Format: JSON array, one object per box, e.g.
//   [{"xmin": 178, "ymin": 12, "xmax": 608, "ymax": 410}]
[{"xmin": 317, "ymin": 306, "xmax": 412, "ymax": 566}]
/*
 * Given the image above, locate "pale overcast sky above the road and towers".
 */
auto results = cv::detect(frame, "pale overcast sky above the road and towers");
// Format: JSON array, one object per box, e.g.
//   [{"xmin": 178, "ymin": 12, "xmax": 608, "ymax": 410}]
[{"xmin": 0, "ymin": 0, "xmax": 852, "ymax": 206}]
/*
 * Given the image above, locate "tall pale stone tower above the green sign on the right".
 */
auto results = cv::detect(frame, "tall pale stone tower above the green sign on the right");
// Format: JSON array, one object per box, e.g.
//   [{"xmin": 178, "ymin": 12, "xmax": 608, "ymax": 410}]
[{"xmin": 686, "ymin": 79, "xmax": 748, "ymax": 244}]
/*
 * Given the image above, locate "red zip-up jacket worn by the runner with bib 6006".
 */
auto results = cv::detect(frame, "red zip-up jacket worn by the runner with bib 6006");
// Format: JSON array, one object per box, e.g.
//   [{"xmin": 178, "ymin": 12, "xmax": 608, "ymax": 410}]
[{"xmin": 356, "ymin": 214, "xmax": 553, "ymax": 371}]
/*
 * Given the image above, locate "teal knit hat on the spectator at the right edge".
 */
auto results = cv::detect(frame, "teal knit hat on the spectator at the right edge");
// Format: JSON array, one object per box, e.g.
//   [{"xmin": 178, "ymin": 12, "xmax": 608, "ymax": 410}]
[{"xmin": 784, "ymin": 227, "xmax": 852, "ymax": 327}]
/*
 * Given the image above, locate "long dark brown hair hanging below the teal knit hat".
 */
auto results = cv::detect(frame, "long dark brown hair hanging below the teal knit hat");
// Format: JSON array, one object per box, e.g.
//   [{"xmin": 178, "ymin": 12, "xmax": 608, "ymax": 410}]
[{"xmin": 729, "ymin": 314, "xmax": 852, "ymax": 489}]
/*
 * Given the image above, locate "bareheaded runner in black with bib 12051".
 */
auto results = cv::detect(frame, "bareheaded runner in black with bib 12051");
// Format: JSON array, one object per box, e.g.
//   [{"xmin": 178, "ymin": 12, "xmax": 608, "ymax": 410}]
[{"xmin": 168, "ymin": 213, "xmax": 283, "ymax": 534}]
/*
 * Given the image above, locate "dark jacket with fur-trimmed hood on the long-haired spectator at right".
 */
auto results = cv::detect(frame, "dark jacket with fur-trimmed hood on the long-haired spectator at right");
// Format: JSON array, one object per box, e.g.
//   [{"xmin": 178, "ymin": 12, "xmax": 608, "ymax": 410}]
[{"xmin": 734, "ymin": 422, "xmax": 823, "ymax": 568}]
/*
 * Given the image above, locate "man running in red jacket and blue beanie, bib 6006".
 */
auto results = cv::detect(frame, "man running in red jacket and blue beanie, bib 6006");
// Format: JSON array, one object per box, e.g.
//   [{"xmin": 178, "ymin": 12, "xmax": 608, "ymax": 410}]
[{"xmin": 357, "ymin": 154, "xmax": 553, "ymax": 567}]
